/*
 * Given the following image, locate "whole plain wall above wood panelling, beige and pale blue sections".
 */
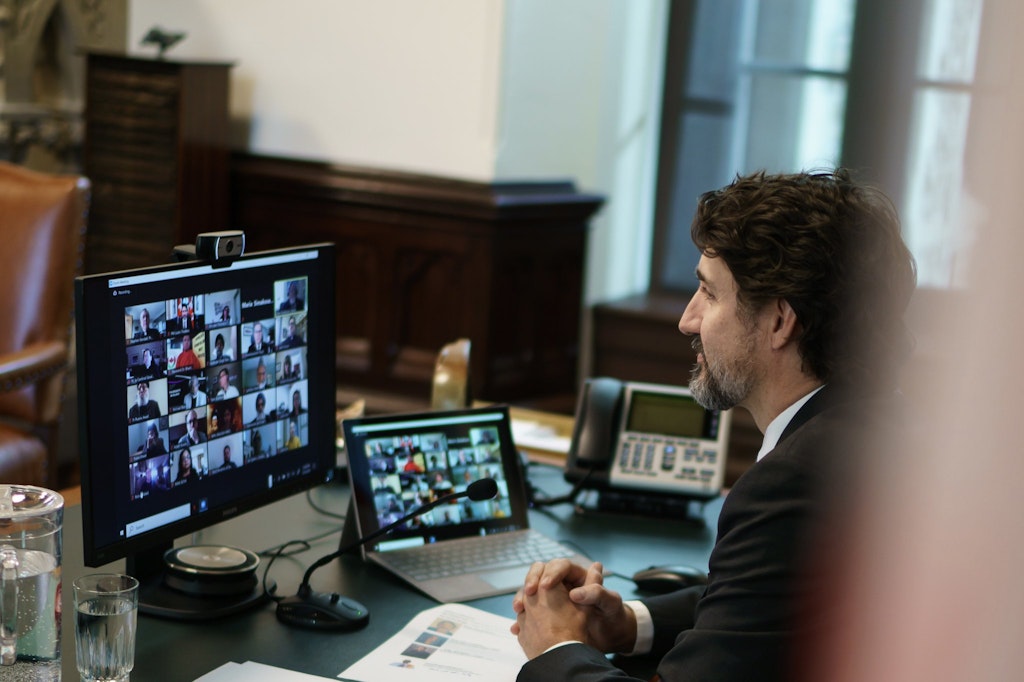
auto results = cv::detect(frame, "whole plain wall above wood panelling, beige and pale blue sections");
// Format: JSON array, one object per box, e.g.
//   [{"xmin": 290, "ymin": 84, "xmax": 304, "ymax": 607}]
[{"xmin": 128, "ymin": 0, "xmax": 668, "ymax": 301}]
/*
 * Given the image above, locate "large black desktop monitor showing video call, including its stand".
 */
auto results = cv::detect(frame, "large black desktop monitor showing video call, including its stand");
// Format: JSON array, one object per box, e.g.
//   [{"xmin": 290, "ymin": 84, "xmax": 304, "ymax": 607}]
[{"xmin": 75, "ymin": 244, "xmax": 336, "ymax": 620}]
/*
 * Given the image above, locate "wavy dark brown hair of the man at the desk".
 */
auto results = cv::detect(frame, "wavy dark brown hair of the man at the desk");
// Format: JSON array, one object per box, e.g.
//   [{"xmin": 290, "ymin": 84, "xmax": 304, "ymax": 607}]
[{"xmin": 690, "ymin": 169, "xmax": 916, "ymax": 385}]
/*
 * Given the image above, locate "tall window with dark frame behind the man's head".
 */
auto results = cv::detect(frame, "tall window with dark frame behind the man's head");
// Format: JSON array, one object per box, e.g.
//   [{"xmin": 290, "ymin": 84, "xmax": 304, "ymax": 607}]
[{"xmin": 650, "ymin": 0, "xmax": 982, "ymax": 292}]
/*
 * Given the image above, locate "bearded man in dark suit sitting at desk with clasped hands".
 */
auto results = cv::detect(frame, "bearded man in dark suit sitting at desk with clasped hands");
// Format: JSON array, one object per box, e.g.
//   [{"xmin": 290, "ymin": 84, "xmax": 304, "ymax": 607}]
[{"xmin": 512, "ymin": 171, "xmax": 915, "ymax": 682}]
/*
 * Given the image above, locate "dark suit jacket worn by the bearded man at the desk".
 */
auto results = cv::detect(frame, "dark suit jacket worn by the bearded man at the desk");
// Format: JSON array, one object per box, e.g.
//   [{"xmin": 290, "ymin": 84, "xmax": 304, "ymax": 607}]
[{"xmin": 518, "ymin": 386, "xmax": 893, "ymax": 682}]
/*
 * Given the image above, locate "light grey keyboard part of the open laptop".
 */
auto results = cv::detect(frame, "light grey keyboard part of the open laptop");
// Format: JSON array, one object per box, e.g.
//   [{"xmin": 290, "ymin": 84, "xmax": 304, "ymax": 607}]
[{"xmin": 380, "ymin": 530, "xmax": 574, "ymax": 581}]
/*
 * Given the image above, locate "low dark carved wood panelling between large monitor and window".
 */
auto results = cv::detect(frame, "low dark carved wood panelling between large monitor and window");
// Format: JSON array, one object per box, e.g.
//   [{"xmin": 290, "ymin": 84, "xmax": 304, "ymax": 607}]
[{"xmin": 231, "ymin": 155, "xmax": 603, "ymax": 411}]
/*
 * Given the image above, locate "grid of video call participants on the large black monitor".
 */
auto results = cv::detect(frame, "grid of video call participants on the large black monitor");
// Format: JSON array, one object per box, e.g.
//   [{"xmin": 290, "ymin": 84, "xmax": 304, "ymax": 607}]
[{"xmin": 124, "ymin": 278, "xmax": 309, "ymax": 500}]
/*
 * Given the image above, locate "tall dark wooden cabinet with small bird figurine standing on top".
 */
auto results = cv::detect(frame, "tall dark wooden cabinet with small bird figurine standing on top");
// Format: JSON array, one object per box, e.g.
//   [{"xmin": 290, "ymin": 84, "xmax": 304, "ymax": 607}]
[{"xmin": 83, "ymin": 52, "xmax": 230, "ymax": 272}]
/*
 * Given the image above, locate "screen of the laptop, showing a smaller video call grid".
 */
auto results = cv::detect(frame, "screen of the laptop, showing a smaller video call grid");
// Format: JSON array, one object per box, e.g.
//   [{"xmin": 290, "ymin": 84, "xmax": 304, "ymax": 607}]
[{"xmin": 344, "ymin": 407, "xmax": 528, "ymax": 551}]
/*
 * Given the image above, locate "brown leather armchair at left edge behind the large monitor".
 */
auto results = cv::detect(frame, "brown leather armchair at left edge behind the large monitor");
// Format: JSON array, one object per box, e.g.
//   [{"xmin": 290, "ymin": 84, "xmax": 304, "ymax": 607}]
[{"xmin": 0, "ymin": 162, "xmax": 90, "ymax": 487}]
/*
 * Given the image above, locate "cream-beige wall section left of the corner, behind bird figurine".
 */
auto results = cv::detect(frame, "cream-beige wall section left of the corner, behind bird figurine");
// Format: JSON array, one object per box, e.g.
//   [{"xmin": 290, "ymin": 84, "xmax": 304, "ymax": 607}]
[{"xmin": 129, "ymin": 0, "xmax": 504, "ymax": 179}]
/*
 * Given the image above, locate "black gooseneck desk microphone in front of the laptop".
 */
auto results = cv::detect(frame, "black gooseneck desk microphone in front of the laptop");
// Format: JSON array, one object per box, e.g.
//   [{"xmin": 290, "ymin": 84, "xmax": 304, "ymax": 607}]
[{"xmin": 278, "ymin": 478, "xmax": 498, "ymax": 630}]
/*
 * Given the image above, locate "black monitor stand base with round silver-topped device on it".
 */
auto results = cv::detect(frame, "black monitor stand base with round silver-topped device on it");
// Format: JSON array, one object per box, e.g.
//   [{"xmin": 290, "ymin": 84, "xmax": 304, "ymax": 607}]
[{"xmin": 126, "ymin": 545, "xmax": 276, "ymax": 621}]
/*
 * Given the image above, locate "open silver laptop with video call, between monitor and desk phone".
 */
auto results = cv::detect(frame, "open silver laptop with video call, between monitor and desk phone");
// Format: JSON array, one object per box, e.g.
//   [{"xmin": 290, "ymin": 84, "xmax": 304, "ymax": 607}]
[{"xmin": 342, "ymin": 406, "xmax": 591, "ymax": 603}]
